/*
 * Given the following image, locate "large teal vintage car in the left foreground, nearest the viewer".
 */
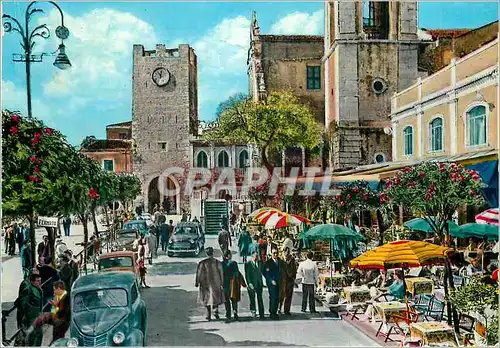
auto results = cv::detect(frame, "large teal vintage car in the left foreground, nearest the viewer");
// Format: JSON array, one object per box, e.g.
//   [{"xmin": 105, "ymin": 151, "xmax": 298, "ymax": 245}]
[{"xmin": 53, "ymin": 272, "xmax": 148, "ymax": 347}]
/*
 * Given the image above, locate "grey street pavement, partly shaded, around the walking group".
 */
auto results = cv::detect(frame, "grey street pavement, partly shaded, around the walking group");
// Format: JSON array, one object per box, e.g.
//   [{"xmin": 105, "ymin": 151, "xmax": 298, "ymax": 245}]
[{"xmin": 2, "ymin": 225, "xmax": 379, "ymax": 347}]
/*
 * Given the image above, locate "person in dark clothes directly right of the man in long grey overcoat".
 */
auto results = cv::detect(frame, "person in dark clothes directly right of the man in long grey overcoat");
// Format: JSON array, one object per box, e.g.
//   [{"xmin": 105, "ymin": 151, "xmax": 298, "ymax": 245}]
[{"xmin": 222, "ymin": 250, "xmax": 246, "ymax": 322}]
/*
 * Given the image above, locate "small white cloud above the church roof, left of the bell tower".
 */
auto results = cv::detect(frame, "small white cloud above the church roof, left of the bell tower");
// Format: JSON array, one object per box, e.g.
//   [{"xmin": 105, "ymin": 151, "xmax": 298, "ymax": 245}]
[{"xmin": 270, "ymin": 10, "xmax": 324, "ymax": 35}]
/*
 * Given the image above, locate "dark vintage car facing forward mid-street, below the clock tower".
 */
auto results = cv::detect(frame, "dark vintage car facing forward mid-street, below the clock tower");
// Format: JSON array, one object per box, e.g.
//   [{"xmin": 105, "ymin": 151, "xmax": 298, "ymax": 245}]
[{"xmin": 167, "ymin": 222, "xmax": 205, "ymax": 256}]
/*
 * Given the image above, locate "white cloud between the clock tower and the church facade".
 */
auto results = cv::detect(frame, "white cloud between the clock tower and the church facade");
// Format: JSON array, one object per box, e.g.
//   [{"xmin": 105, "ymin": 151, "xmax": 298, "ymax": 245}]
[{"xmin": 193, "ymin": 16, "xmax": 250, "ymax": 75}]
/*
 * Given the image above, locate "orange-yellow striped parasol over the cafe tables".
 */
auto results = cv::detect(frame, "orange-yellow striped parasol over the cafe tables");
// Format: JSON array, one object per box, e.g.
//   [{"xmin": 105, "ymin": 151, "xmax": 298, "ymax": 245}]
[{"xmin": 349, "ymin": 240, "xmax": 451, "ymax": 269}]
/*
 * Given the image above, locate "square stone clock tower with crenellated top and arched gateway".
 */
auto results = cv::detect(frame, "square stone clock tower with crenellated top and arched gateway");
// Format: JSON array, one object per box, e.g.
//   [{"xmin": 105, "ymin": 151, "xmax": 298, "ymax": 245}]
[{"xmin": 132, "ymin": 44, "xmax": 198, "ymax": 214}]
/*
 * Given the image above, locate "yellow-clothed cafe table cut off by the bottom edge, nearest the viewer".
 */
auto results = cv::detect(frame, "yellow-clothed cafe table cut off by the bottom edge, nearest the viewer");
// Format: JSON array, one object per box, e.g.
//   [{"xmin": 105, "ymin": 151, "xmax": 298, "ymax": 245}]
[{"xmin": 410, "ymin": 322, "xmax": 459, "ymax": 346}]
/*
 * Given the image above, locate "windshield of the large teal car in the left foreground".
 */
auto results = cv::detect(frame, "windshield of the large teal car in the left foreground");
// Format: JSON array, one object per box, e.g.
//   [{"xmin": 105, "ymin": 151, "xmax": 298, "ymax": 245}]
[{"xmin": 73, "ymin": 289, "xmax": 128, "ymax": 313}]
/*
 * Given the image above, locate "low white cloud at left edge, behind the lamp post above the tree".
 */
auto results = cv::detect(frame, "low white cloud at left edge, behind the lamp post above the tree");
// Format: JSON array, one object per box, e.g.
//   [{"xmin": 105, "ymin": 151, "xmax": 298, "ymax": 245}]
[{"xmin": 2, "ymin": 80, "xmax": 54, "ymax": 127}]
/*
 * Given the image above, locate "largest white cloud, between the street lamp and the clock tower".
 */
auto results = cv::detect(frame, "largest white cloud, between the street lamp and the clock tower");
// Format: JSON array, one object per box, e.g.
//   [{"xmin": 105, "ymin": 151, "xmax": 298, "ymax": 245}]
[{"xmin": 40, "ymin": 8, "xmax": 157, "ymax": 108}]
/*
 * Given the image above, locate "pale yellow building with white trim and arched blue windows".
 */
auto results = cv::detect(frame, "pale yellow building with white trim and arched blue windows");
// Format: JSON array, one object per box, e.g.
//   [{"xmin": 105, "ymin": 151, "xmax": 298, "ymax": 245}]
[{"xmin": 390, "ymin": 38, "xmax": 499, "ymax": 162}]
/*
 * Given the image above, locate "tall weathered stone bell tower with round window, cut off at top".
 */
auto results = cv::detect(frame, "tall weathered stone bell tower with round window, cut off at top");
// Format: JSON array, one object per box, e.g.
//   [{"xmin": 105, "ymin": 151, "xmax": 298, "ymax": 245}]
[{"xmin": 323, "ymin": 1, "xmax": 420, "ymax": 169}]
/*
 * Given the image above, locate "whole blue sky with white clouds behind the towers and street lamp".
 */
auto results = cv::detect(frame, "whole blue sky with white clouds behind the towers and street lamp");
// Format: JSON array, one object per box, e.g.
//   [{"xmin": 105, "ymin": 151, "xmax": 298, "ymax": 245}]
[{"xmin": 2, "ymin": 2, "xmax": 498, "ymax": 145}]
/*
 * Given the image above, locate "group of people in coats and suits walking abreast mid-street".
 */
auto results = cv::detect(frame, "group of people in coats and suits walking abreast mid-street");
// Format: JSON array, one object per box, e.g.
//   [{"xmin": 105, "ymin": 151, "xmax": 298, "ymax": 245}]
[{"xmin": 195, "ymin": 226, "xmax": 318, "ymax": 322}]
